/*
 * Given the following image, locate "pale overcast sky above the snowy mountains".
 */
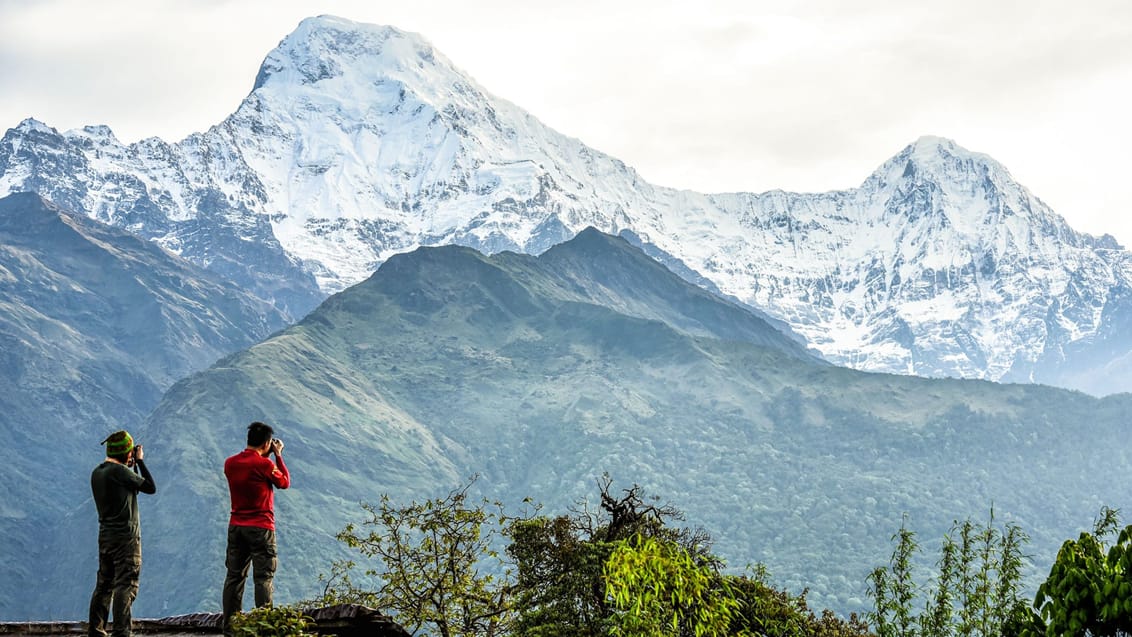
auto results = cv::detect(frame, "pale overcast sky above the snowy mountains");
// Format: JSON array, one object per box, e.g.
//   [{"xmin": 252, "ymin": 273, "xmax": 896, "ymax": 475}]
[{"xmin": 0, "ymin": 0, "xmax": 1132, "ymax": 247}]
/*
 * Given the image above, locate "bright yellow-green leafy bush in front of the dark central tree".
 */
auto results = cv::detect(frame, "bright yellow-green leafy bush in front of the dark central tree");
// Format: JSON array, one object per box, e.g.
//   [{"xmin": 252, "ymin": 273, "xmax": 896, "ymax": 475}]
[{"xmin": 603, "ymin": 536, "xmax": 746, "ymax": 637}]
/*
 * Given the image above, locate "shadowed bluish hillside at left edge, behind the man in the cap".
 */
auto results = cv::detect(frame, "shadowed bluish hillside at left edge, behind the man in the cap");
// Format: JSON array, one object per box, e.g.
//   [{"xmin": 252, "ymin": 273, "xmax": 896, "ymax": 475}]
[{"xmin": 0, "ymin": 193, "xmax": 289, "ymax": 620}]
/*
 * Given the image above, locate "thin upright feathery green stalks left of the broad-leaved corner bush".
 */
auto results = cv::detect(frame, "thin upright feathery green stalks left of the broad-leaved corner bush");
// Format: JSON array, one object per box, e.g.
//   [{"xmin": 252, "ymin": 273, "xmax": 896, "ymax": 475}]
[{"xmin": 868, "ymin": 508, "xmax": 1031, "ymax": 637}]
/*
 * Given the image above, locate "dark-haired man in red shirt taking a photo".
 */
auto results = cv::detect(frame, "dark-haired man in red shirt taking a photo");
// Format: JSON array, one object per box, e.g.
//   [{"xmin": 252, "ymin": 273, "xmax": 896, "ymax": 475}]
[{"xmin": 223, "ymin": 422, "xmax": 291, "ymax": 634}]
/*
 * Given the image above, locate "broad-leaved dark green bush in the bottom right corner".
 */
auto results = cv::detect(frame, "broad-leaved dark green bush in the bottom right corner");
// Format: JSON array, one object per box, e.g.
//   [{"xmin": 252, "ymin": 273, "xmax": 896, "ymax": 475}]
[{"xmin": 1023, "ymin": 507, "xmax": 1132, "ymax": 637}]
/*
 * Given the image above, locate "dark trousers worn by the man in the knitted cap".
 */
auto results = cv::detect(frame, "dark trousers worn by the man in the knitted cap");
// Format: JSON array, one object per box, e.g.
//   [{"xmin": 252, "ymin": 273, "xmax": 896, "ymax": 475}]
[{"xmin": 87, "ymin": 537, "xmax": 142, "ymax": 637}]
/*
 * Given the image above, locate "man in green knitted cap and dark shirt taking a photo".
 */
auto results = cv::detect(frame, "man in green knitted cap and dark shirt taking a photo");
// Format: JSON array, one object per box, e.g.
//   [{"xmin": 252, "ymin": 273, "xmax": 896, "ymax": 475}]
[{"xmin": 88, "ymin": 431, "xmax": 157, "ymax": 637}]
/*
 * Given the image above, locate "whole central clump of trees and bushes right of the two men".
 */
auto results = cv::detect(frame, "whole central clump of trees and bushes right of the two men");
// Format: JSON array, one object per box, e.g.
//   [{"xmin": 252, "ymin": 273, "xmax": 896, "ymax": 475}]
[{"xmin": 323, "ymin": 475, "xmax": 871, "ymax": 637}]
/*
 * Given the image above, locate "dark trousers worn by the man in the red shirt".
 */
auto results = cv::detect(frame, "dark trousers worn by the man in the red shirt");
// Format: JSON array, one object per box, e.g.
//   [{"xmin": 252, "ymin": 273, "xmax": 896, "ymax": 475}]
[{"xmin": 223, "ymin": 525, "xmax": 278, "ymax": 632}]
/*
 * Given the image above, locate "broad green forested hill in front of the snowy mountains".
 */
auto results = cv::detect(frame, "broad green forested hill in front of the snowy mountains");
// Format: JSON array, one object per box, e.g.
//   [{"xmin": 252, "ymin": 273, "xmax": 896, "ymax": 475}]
[{"xmin": 66, "ymin": 232, "xmax": 1132, "ymax": 614}]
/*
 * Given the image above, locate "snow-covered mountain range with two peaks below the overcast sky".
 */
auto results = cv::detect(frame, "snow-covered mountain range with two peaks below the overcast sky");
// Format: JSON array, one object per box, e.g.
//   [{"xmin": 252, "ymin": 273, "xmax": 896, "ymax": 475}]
[{"xmin": 0, "ymin": 16, "xmax": 1132, "ymax": 394}]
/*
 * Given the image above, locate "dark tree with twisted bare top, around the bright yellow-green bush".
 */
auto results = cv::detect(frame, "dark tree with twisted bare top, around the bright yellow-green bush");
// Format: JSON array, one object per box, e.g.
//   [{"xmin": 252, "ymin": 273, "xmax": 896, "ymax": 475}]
[{"xmin": 507, "ymin": 475, "xmax": 869, "ymax": 637}]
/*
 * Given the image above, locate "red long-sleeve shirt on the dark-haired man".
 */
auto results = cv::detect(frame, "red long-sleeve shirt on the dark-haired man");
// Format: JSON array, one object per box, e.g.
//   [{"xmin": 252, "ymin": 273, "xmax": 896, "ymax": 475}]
[{"xmin": 224, "ymin": 449, "xmax": 291, "ymax": 531}]
